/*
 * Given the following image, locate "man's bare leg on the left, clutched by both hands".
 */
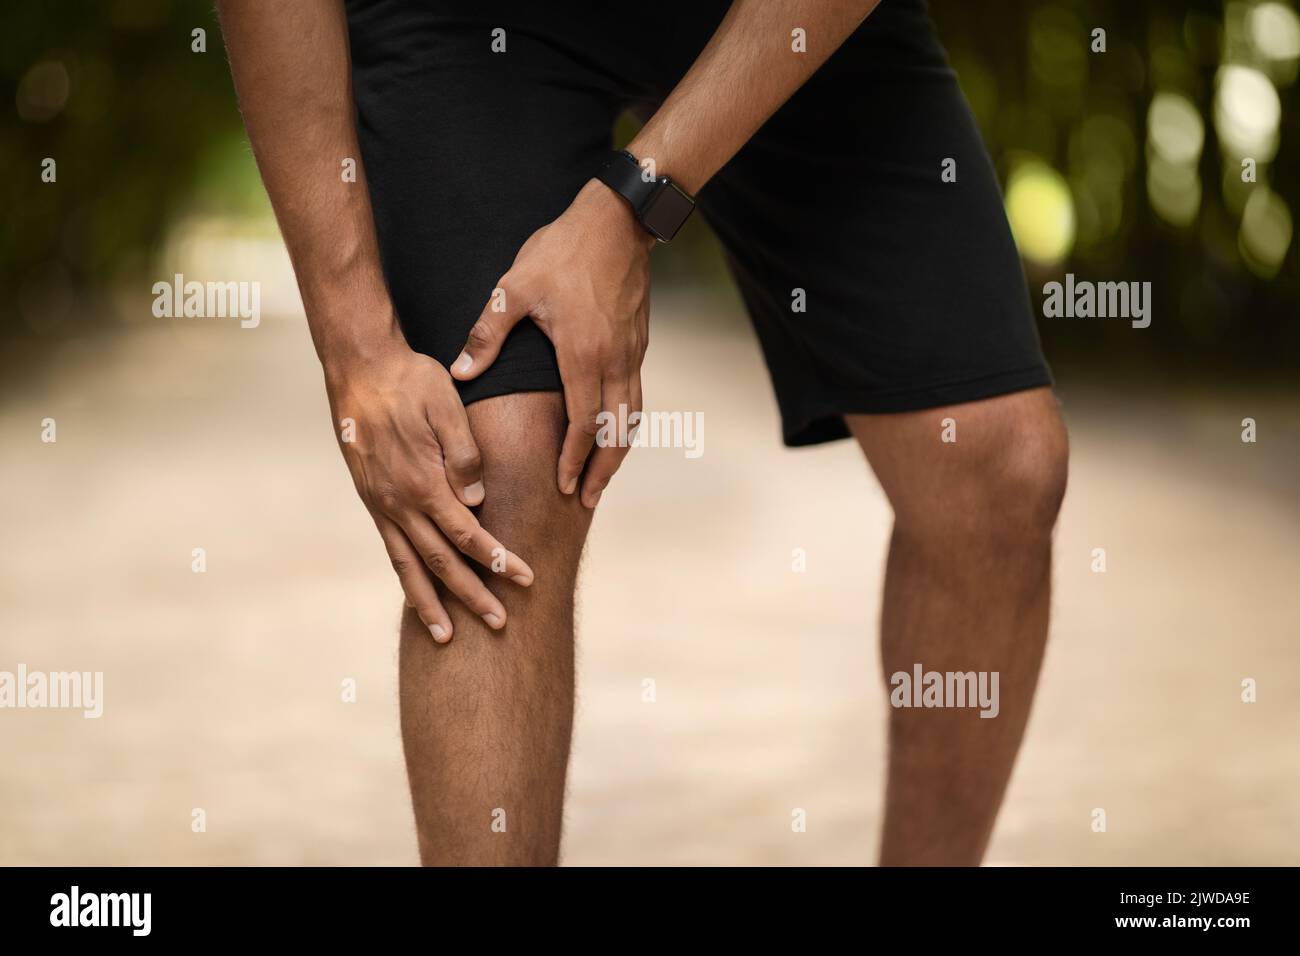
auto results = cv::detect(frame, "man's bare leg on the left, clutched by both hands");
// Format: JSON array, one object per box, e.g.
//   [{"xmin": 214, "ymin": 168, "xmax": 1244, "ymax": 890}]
[{"xmin": 400, "ymin": 392, "xmax": 592, "ymax": 865}]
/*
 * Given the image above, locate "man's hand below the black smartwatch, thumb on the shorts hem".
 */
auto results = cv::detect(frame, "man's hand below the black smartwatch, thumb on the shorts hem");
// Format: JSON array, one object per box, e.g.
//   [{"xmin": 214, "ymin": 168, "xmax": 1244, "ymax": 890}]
[{"xmin": 451, "ymin": 179, "xmax": 654, "ymax": 507}]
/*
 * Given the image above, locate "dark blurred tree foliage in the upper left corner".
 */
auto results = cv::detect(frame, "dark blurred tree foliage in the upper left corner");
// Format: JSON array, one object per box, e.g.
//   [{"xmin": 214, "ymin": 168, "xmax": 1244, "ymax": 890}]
[{"xmin": 0, "ymin": 0, "xmax": 239, "ymax": 332}]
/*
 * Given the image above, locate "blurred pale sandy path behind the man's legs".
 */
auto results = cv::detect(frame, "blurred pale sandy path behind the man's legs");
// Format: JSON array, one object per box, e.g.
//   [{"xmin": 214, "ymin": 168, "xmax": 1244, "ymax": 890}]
[{"xmin": 0, "ymin": 303, "xmax": 1300, "ymax": 864}]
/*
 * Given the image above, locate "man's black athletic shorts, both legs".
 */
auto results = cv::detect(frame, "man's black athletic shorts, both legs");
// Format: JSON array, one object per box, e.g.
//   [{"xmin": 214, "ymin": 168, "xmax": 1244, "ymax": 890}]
[{"xmin": 347, "ymin": 0, "xmax": 1050, "ymax": 445}]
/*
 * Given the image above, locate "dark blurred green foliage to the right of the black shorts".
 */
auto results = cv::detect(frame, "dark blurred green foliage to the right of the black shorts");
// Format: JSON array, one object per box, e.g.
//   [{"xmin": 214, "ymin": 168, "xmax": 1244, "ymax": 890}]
[{"xmin": 935, "ymin": 0, "xmax": 1300, "ymax": 375}]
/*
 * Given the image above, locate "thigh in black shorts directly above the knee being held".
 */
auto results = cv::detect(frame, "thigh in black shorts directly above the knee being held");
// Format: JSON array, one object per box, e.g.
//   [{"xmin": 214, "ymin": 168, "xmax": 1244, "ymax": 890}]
[{"xmin": 348, "ymin": 0, "xmax": 619, "ymax": 402}]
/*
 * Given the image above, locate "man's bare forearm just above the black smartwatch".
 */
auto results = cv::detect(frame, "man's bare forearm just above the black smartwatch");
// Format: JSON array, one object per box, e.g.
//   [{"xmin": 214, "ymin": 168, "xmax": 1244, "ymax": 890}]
[{"xmin": 628, "ymin": 0, "xmax": 879, "ymax": 193}]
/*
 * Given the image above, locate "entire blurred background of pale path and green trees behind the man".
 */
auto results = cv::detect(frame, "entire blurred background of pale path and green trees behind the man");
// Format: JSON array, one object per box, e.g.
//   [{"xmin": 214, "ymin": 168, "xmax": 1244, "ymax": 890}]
[{"xmin": 0, "ymin": 0, "xmax": 1300, "ymax": 864}]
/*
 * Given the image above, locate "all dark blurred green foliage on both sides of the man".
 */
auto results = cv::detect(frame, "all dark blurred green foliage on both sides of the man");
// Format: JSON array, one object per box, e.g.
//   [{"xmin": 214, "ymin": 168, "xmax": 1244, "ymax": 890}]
[{"xmin": 0, "ymin": 0, "xmax": 1300, "ymax": 369}]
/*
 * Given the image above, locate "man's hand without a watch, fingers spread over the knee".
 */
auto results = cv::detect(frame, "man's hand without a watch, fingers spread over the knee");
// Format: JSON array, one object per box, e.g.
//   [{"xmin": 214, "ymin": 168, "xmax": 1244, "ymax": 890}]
[{"xmin": 325, "ymin": 332, "xmax": 533, "ymax": 643}]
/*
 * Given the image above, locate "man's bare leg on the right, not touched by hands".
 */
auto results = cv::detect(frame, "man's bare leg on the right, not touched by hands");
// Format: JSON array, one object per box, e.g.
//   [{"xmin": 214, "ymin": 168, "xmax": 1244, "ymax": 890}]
[{"xmin": 846, "ymin": 389, "xmax": 1067, "ymax": 865}]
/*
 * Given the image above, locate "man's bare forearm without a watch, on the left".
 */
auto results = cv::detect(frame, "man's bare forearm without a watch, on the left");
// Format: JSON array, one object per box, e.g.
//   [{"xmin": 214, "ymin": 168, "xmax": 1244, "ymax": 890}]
[{"xmin": 217, "ymin": 0, "xmax": 400, "ymax": 368}]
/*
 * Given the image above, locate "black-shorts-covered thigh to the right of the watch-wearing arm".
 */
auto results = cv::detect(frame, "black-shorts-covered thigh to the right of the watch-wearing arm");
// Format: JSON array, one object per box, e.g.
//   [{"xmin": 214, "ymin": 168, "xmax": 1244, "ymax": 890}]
[{"xmin": 701, "ymin": 0, "xmax": 1049, "ymax": 445}]
